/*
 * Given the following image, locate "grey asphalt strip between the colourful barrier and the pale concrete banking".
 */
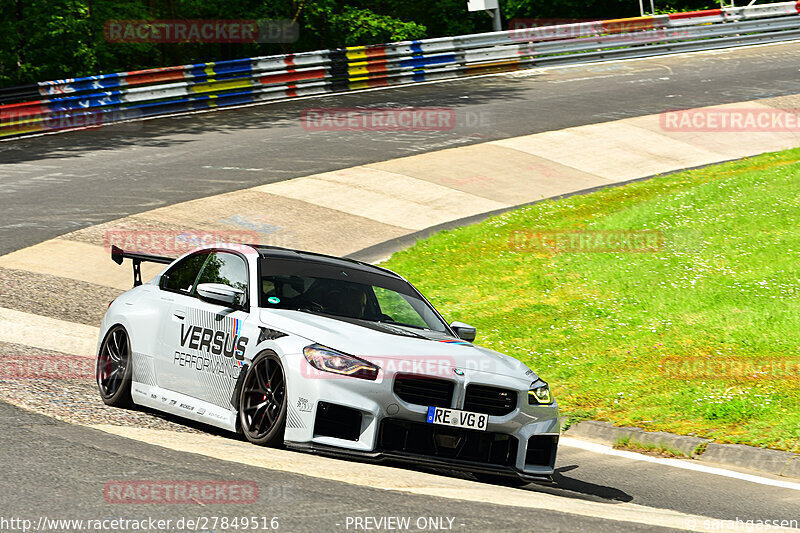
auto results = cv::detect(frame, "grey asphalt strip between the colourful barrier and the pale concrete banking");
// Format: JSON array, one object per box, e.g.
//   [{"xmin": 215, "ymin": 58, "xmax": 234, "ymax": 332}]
[{"xmin": 0, "ymin": 44, "xmax": 800, "ymax": 255}]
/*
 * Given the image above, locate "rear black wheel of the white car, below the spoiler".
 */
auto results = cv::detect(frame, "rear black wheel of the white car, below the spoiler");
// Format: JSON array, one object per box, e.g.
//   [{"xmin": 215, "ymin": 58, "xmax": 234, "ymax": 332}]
[{"xmin": 95, "ymin": 326, "xmax": 133, "ymax": 408}]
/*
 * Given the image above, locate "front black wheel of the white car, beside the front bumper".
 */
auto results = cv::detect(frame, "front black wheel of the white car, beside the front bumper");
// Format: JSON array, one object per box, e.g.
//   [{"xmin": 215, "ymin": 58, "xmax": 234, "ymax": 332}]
[{"xmin": 239, "ymin": 352, "xmax": 287, "ymax": 446}]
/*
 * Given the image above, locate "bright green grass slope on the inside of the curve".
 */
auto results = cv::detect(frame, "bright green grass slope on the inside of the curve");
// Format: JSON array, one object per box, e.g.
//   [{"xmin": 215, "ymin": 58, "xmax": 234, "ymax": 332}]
[{"xmin": 385, "ymin": 149, "xmax": 800, "ymax": 452}]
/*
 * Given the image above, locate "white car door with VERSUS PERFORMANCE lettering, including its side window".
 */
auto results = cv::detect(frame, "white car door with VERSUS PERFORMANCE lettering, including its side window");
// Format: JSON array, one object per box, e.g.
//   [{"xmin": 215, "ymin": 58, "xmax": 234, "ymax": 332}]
[{"xmin": 164, "ymin": 250, "xmax": 258, "ymax": 409}]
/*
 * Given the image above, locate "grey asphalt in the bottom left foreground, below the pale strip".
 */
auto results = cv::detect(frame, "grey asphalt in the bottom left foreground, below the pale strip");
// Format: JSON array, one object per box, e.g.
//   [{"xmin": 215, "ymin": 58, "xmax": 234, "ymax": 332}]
[{"xmin": 0, "ymin": 402, "xmax": 680, "ymax": 532}]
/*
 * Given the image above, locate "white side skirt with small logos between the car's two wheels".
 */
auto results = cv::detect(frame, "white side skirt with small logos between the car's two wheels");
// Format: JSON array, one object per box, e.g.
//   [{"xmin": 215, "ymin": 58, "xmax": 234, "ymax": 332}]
[{"xmin": 131, "ymin": 381, "xmax": 237, "ymax": 432}]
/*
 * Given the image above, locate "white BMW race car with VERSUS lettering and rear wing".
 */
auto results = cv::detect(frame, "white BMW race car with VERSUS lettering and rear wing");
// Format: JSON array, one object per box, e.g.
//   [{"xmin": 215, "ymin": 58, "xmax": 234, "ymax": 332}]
[{"xmin": 96, "ymin": 245, "xmax": 559, "ymax": 484}]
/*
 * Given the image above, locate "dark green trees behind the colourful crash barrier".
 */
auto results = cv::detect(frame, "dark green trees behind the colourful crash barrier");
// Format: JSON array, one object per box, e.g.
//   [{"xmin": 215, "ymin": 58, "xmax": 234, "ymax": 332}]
[{"xmin": 0, "ymin": 0, "xmax": 713, "ymax": 86}]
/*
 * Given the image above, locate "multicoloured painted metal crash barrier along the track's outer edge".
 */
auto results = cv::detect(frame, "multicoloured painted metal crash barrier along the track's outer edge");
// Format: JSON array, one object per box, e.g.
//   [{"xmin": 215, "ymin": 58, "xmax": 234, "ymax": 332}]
[{"xmin": 0, "ymin": 1, "xmax": 800, "ymax": 137}]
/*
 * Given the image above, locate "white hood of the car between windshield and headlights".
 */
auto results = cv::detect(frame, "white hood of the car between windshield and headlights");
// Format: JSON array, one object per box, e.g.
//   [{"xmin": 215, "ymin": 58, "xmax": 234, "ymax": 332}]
[{"xmin": 260, "ymin": 309, "xmax": 537, "ymax": 381}]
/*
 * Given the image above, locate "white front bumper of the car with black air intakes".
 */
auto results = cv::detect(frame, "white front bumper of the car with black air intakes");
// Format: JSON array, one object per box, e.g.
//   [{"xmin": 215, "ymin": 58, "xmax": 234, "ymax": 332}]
[{"xmin": 285, "ymin": 358, "xmax": 560, "ymax": 481}]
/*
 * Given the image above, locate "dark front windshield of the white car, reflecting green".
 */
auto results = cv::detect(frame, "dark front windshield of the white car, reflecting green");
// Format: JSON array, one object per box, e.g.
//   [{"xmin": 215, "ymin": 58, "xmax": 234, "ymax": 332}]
[{"xmin": 261, "ymin": 259, "xmax": 447, "ymax": 332}]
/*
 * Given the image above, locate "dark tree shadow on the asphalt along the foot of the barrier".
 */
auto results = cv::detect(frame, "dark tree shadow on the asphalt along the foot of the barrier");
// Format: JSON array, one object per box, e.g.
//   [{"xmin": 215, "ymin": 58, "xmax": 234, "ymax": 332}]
[{"xmin": 0, "ymin": 79, "xmax": 536, "ymax": 163}]
